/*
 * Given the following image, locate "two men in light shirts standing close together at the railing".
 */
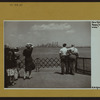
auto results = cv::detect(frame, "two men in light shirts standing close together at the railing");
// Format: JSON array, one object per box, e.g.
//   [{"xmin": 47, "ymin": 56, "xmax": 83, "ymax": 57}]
[{"xmin": 59, "ymin": 43, "xmax": 79, "ymax": 75}]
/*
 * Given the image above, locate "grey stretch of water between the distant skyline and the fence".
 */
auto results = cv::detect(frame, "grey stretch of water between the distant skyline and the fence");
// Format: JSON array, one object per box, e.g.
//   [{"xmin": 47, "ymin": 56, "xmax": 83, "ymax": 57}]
[{"xmin": 32, "ymin": 48, "xmax": 91, "ymax": 58}]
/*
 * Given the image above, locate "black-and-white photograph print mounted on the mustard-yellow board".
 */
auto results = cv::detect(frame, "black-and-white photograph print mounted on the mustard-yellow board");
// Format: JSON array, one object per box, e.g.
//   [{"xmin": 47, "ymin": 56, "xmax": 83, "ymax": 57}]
[{"xmin": 4, "ymin": 20, "xmax": 91, "ymax": 89}]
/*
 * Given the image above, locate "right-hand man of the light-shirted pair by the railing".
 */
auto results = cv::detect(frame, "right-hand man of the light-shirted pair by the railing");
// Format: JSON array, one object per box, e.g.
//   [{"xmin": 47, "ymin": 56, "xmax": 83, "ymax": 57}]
[{"xmin": 68, "ymin": 45, "xmax": 79, "ymax": 75}]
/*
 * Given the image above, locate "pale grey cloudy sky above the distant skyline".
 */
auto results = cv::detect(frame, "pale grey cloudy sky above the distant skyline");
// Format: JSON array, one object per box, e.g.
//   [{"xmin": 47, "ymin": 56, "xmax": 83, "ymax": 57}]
[{"xmin": 4, "ymin": 20, "xmax": 91, "ymax": 47}]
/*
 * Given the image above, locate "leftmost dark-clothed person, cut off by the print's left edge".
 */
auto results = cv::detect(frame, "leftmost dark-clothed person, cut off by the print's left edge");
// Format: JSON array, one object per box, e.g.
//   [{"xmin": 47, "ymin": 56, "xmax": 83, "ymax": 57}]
[{"xmin": 5, "ymin": 46, "xmax": 15, "ymax": 87}]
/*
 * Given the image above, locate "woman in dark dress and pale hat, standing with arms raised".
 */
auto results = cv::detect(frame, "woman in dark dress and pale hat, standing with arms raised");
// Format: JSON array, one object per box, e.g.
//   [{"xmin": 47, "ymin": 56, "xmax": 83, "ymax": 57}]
[{"xmin": 23, "ymin": 43, "xmax": 35, "ymax": 79}]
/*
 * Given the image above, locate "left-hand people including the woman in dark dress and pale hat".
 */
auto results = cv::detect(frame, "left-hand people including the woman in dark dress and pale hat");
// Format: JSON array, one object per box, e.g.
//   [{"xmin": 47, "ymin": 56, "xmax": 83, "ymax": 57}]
[{"xmin": 4, "ymin": 43, "xmax": 35, "ymax": 87}]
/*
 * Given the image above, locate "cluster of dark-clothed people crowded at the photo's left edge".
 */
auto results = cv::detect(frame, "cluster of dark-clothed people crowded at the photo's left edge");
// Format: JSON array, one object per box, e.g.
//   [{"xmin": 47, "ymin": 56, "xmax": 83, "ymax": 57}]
[{"xmin": 4, "ymin": 45, "xmax": 20, "ymax": 87}]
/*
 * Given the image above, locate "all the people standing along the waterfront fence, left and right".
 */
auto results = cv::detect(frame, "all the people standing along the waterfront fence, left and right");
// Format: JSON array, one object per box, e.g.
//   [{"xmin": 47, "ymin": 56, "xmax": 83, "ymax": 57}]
[{"xmin": 5, "ymin": 43, "xmax": 79, "ymax": 87}]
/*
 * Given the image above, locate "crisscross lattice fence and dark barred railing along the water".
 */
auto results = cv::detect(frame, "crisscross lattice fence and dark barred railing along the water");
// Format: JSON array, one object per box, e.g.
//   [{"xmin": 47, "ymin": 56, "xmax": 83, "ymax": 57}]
[{"xmin": 19, "ymin": 57, "xmax": 91, "ymax": 74}]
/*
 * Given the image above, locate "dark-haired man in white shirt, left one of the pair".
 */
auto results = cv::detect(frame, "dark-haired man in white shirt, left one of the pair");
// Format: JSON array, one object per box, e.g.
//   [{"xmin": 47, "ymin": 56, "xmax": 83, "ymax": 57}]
[{"xmin": 59, "ymin": 43, "xmax": 69, "ymax": 74}]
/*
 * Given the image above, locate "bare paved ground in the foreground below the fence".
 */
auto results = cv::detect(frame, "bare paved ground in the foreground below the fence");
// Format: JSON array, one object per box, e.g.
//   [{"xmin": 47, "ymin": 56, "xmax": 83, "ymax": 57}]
[{"xmin": 9, "ymin": 68, "xmax": 91, "ymax": 89}]
